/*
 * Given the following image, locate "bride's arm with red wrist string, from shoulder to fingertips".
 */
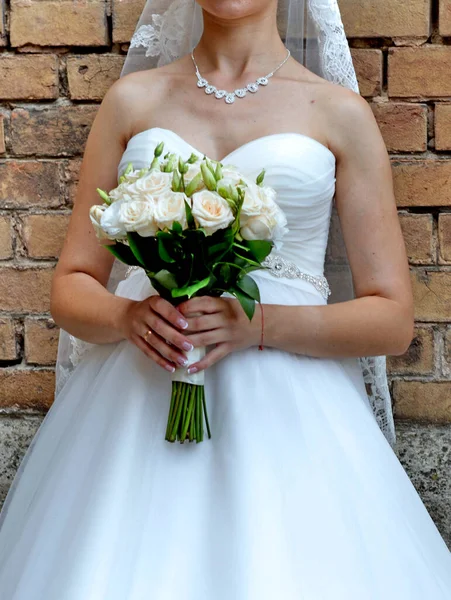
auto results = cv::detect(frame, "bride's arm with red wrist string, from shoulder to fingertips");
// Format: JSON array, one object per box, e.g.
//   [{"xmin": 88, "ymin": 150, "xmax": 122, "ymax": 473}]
[{"xmin": 179, "ymin": 90, "xmax": 414, "ymax": 368}]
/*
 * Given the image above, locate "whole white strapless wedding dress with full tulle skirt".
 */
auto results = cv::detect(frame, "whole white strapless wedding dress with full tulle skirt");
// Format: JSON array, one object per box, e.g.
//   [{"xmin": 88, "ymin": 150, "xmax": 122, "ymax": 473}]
[{"xmin": 0, "ymin": 128, "xmax": 451, "ymax": 600}]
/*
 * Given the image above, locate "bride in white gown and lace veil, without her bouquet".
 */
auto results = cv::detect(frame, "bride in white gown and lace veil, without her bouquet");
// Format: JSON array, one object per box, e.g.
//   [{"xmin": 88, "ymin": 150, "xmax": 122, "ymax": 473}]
[{"xmin": 0, "ymin": 0, "xmax": 451, "ymax": 600}]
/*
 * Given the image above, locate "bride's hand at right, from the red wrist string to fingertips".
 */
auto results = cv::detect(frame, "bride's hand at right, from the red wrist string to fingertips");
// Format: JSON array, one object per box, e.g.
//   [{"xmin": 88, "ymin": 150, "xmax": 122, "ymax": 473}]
[{"xmin": 177, "ymin": 296, "xmax": 261, "ymax": 373}]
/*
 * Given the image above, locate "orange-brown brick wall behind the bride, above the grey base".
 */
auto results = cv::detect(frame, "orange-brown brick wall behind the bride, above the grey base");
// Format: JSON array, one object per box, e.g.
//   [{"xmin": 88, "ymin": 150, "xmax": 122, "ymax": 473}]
[{"xmin": 0, "ymin": 0, "xmax": 451, "ymax": 466}]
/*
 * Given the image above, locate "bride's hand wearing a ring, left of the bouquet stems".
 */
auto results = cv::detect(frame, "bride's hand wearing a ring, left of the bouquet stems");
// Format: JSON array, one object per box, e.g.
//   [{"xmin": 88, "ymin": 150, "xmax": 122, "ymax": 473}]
[{"xmin": 120, "ymin": 295, "xmax": 193, "ymax": 373}]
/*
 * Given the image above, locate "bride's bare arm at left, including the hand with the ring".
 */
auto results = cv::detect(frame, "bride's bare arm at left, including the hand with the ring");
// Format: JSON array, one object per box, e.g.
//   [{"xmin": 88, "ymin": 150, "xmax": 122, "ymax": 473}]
[{"xmin": 50, "ymin": 78, "xmax": 191, "ymax": 370}]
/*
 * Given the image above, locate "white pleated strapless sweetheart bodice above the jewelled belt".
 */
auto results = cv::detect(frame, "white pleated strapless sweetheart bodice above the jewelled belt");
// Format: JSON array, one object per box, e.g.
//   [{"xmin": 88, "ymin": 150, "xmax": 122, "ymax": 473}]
[{"xmin": 118, "ymin": 127, "xmax": 336, "ymax": 275}]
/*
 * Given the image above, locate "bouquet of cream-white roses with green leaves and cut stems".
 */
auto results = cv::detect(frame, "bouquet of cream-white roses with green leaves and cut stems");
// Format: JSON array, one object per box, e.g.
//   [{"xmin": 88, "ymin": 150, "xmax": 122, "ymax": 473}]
[{"xmin": 90, "ymin": 143, "xmax": 286, "ymax": 442}]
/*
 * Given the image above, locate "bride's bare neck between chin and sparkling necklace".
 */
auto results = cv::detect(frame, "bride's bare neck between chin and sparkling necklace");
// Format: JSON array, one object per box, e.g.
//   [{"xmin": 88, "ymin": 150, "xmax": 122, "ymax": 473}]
[{"xmin": 194, "ymin": 13, "xmax": 286, "ymax": 77}]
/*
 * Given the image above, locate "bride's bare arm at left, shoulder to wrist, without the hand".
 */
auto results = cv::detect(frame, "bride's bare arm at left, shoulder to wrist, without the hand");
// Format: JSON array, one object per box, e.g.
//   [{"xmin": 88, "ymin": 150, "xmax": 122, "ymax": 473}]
[{"xmin": 50, "ymin": 80, "xmax": 134, "ymax": 343}]
